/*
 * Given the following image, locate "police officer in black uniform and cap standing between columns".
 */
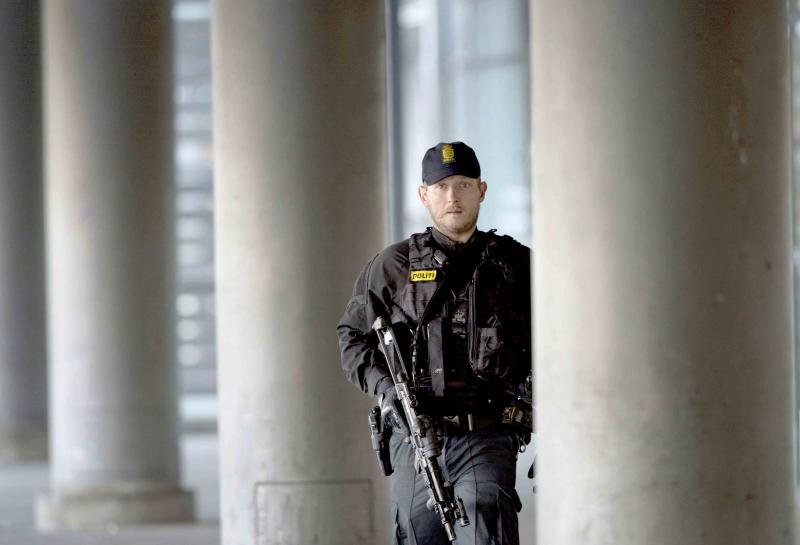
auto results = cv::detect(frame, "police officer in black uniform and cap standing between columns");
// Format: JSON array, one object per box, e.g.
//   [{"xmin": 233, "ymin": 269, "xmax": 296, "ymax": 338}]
[{"xmin": 337, "ymin": 142, "xmax": 531, "ymax": 545}]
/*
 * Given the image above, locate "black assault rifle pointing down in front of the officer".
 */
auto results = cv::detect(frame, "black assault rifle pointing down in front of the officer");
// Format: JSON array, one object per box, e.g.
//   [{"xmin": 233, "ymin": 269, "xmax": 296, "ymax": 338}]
[{"xmin": 372, "ymin": 317, "xmax": 469, "ymax": 541}]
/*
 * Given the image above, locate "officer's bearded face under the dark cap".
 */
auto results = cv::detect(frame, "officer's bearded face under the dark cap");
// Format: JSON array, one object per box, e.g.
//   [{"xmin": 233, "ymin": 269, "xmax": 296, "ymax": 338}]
[{"xmin": 419, "ymin": 175, "xmax": 486, "ymax": 242}]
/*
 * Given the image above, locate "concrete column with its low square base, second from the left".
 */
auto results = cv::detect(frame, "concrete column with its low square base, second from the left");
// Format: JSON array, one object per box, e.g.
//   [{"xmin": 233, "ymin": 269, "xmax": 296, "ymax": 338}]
[{"xmin": 37, "ymin": 0, "xmax": 192, "ymax": 529}]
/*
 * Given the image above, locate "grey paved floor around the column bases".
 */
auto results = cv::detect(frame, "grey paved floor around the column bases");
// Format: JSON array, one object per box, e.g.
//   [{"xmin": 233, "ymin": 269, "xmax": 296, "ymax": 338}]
[{"xmin": 0, "ymin": 431, "xmax": 535, "ymax": 545}]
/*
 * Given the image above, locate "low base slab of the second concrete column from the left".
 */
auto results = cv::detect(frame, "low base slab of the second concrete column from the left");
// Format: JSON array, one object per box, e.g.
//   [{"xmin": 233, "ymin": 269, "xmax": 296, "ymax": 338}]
[{"xmin": 36, "ymin": 486, "xmax": 194, "ymax": 532}]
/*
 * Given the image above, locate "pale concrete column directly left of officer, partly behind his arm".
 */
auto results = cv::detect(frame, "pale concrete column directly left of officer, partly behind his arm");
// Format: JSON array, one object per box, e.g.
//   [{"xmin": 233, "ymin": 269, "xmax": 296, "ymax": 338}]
[{"xmin": 212, "ymin": 0, "xmax": 389, "ymax": 545}]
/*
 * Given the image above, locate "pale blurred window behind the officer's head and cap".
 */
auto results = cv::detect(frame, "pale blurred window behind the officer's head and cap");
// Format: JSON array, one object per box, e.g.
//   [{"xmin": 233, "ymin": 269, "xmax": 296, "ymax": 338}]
[{"xmin": 387, "ymin": 0, "xmax": 532, "ymax": 245}]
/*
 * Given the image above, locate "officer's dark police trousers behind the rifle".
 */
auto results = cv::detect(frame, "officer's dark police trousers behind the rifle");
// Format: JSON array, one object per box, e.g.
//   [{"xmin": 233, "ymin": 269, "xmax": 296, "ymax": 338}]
[{"xmin": 390, "ymin": 429, "xmax": 522, "ymax": 545}]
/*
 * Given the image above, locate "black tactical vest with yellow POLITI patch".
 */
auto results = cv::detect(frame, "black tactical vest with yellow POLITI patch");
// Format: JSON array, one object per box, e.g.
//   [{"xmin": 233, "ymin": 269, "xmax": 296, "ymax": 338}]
[{"xmin": 400, "ymin": 230, "xmax": 531, "ymax": 398}]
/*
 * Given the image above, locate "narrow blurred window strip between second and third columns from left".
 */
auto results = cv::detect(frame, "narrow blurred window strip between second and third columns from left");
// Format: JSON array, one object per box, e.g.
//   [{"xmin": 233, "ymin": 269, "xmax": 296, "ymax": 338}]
[{"xmin": 172, "ymin": 0, "xmax": 216, "ymax": 400}]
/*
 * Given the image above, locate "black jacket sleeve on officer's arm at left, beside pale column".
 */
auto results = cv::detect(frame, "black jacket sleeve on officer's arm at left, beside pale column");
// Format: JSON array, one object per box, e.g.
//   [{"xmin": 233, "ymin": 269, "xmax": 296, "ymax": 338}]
[{"xmin": 336, "ymin": 256, "xmax": 389, "ymax": 395}]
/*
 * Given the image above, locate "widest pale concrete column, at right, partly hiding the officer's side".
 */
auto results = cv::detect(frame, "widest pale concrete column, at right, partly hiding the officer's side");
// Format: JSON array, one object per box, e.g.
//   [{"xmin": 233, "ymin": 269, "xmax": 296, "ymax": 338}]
[{"xmin": 532, "ymin": 0, "xmax": 794, "ymax": 545}]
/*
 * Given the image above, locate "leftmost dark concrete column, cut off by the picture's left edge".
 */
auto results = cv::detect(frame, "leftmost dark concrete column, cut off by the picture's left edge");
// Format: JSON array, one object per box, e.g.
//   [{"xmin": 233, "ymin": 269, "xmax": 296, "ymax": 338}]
[{"xmin": 0, "ymin": 0, "xmax": 47, "ymax": 462}]
